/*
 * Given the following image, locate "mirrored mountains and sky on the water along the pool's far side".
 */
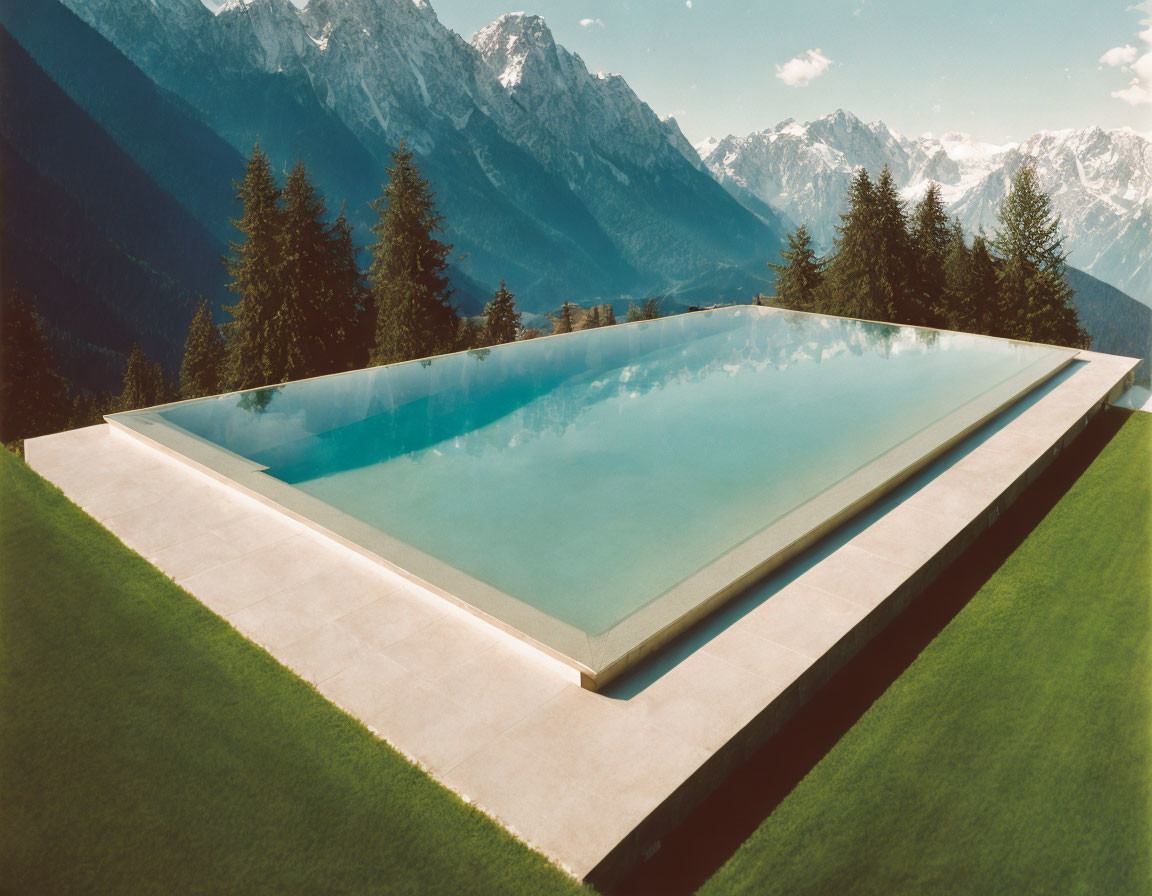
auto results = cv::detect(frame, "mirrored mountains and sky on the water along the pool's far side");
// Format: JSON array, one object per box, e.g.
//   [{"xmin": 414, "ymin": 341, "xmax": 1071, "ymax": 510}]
[{"xmin": 166, "ymin": 310, "xmax": 1036, "ymax": 480}]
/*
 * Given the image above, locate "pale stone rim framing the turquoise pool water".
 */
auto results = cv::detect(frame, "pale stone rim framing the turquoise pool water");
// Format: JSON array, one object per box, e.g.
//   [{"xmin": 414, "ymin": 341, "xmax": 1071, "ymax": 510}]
[{"xmin": 105, "ymin": 305, "xmax": 1076, "ymax": 691}]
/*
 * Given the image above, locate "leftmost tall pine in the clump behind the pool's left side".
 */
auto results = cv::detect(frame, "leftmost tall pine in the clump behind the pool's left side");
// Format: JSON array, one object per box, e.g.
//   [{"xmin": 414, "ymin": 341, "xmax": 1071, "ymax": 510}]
[{"xmin": 223, "ymin": 144, "xmax": 283, "ymax": 389}]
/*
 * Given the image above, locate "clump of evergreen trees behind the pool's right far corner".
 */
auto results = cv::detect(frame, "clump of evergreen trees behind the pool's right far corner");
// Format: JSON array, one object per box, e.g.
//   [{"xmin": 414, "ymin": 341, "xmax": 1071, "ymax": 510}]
[{"xmin": 770, "ymin": 165, "xmax": 1090, "ymax": 348}]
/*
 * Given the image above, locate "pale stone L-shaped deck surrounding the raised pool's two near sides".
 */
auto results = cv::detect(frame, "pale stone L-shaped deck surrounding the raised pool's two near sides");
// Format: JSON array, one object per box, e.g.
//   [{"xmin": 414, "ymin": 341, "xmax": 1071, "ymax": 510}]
[{"xmin": 25, "ymin": 352, "xmax": 1137, "ymax": 884}]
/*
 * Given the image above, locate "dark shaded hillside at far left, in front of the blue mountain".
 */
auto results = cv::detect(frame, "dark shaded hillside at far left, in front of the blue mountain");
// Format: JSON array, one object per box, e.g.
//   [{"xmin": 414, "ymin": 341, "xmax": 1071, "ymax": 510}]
[{"xmin": 0, "ymin": 29, "xmax": 223, "ymax": 388}]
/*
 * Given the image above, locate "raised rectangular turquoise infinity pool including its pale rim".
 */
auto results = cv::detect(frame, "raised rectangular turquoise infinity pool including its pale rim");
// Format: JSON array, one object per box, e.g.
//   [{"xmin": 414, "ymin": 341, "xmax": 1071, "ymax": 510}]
[{"xmin": 109, "ymin": 306, "xmax": 1075, "ymax": 684}]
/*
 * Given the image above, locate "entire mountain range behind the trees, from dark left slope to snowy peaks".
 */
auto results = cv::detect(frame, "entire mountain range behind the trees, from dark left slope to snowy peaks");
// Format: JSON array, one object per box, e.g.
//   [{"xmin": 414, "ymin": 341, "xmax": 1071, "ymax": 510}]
[{"xmin": 0, "ymin": 0, "xmax": 1152, "ymax": 389}]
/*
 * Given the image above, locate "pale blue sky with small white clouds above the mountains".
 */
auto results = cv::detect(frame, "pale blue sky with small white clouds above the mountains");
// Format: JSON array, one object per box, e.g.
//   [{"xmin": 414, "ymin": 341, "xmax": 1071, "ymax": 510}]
[{"xmin": 245, "ymin": 0, "xmax": 1152, "ymax": 143}]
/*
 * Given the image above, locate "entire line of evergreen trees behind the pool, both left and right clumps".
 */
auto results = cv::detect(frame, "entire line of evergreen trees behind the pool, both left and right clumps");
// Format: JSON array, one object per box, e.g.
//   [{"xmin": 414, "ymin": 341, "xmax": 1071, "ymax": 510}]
[{"xmin": 0, "ymin": 143, "xmax": 1089, "ymax": 445}]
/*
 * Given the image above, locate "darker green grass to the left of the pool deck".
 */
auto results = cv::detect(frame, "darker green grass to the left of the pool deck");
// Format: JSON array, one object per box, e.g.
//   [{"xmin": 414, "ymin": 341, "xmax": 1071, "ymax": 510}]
[{"xmin": 0, "ymin": 451, "xmax": 579, "ymax": 894}]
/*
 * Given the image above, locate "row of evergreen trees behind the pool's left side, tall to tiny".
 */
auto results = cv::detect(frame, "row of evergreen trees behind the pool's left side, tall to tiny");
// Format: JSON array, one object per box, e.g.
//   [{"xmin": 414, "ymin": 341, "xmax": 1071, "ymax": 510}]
[{"xmin": 0, "ymin": 143, "xmax": 661, "ymax": 445}]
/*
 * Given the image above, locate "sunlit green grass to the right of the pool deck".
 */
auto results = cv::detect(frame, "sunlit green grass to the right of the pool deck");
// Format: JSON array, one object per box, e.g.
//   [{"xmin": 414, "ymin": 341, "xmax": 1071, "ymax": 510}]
[{"xmin": 702, "ymin": 411, "xmax": 1152, "ymax": 894}]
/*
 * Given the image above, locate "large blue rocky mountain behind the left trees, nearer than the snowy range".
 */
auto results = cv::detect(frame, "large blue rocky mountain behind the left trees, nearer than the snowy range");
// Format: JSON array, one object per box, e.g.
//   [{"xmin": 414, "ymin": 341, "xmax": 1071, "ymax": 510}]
[{"xmin": 54, "ymin": 0, "xmax": 783, "ymax": 307}]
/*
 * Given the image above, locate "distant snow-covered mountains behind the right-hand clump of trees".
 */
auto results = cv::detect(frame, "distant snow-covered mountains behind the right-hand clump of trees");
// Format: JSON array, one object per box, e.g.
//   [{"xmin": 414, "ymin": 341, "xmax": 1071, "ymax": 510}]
[{"xmin": 696, "ymin": 109, "xmax": 1152, "ymax": 304}]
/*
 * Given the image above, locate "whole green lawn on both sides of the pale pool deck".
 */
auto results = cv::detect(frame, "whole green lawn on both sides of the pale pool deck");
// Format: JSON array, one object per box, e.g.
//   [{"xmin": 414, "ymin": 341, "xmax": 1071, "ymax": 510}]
[{"xmin": 0, "ymin": 412, "xmax": 1152, "ymax": 894}]
